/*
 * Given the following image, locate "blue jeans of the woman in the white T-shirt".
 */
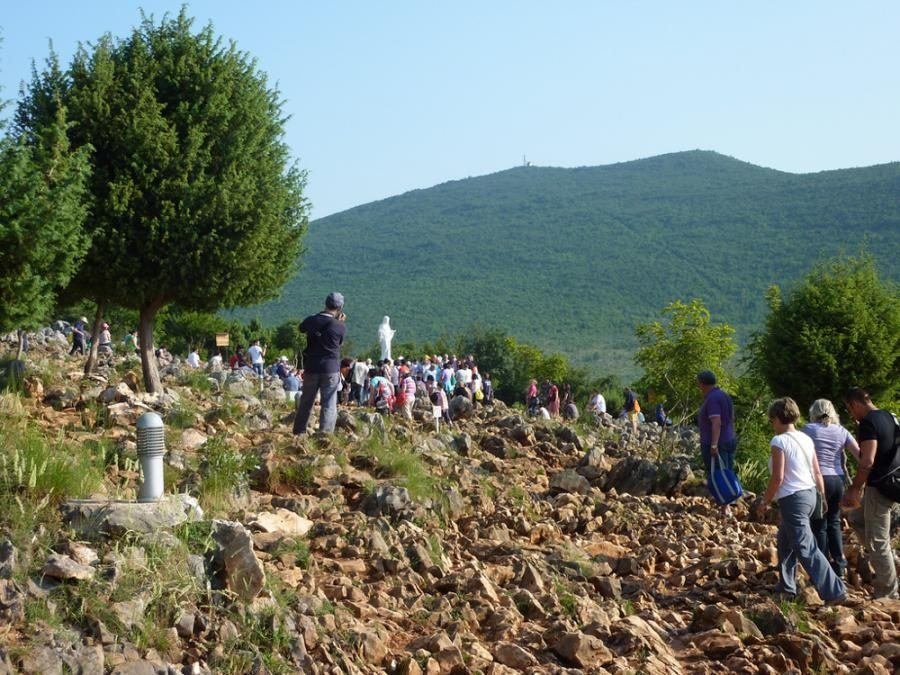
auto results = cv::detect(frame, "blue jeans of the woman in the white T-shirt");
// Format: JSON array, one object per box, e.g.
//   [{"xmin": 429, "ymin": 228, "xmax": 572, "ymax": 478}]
[{"xmin": 778, "ymin": 488, "xmax": 847, "ymax": 602}]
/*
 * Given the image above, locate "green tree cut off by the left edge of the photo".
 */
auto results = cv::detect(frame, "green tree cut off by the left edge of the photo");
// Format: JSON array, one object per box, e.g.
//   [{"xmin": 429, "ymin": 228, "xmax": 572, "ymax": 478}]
[{"xmin": 0, "ymin": 62, "xmax": 89, "ymax": 358}]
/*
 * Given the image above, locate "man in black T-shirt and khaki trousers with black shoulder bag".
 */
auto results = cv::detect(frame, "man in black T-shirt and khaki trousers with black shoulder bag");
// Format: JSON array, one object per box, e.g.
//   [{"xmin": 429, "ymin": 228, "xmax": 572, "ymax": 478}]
[{"xmin": 841, "ymin": 389, "xmax": 900, "ymax": 598}]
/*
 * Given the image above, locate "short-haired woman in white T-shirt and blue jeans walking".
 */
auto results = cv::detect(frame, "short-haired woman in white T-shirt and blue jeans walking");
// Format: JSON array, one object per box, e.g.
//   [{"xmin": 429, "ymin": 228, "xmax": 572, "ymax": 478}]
[{"xmin": 758, "ymin": 398, "xmax": 847, "ymax": 604}]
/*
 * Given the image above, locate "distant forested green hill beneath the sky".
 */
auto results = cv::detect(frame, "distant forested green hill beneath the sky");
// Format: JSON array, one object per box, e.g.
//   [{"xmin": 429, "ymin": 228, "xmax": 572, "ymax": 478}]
[{"xmin": 240, "ymin": 151, "xmax": 900, "ymax": 375}]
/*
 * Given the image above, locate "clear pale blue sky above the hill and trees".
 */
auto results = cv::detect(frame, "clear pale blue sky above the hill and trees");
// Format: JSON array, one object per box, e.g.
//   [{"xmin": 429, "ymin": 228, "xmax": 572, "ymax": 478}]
[{"xmin": 0, "ymin": 0, "xmax": 900, "ymax": 217}]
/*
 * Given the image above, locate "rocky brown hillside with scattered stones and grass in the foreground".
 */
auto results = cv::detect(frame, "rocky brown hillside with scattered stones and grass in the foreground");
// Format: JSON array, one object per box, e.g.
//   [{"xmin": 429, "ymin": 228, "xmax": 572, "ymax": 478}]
[{"xmin": 0, "ymin": 335, "xmax": 900, "ymax": 675}]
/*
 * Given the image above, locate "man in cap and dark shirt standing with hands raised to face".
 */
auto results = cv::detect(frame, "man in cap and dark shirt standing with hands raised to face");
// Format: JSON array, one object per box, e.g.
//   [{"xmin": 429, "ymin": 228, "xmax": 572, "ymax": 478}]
[{"xmin": 294, "ymin": 293, "xmax": 347, "ymax": 434}]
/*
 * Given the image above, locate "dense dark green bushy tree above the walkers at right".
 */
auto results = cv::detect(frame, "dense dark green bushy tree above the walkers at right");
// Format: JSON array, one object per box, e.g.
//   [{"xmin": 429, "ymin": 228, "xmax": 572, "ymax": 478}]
[{"xmin": 750, "ymin": 253, "xmax": 900, "ymax": 407}]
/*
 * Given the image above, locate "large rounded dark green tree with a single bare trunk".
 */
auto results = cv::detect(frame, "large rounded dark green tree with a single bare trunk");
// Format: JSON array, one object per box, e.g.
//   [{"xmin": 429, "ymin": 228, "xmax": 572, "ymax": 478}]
[{"xmin": 17, "ymin": 10, "xmax": 308, "ymax": 392}]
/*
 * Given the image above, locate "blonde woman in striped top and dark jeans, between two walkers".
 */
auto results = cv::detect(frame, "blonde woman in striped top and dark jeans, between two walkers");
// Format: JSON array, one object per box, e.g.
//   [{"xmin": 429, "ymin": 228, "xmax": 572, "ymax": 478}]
[{"xmin": 803, "ymin": 398, "xmax": 859, "ymax": 579}]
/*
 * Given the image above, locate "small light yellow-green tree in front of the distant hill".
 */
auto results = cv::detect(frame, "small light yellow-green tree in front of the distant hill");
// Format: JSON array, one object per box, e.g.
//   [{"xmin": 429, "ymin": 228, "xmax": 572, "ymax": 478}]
[{"xmin": 634, "ymin": 299, "xmax": 737, "ymax": 418}]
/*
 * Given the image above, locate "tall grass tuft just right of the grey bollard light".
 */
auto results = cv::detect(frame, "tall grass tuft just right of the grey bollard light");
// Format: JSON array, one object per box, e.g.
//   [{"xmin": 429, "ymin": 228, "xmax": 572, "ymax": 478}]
[{"xmin": 199, "ymin": 436, "xmax": 256, "ymax": 514}]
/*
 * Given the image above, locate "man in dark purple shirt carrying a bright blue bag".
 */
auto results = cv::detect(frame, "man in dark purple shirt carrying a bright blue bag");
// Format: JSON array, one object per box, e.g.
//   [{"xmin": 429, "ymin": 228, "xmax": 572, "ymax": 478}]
[{"xmin": 697, "ymin": 370, "xmax": 743, "ymax": 515}]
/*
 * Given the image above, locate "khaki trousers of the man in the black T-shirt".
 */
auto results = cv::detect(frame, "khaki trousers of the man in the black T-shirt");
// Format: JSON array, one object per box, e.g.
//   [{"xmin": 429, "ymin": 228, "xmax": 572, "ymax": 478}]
[{"xmin": 847, "ymin": 486, "xmax": 897, "ymax": 598}]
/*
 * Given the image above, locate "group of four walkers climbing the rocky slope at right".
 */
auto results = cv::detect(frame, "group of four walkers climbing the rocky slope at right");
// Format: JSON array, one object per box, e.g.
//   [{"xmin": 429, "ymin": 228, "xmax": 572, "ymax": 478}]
[{"xmin": 697, "ymin": 371, "xmax": 900, "ymax": 604}]
